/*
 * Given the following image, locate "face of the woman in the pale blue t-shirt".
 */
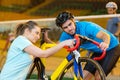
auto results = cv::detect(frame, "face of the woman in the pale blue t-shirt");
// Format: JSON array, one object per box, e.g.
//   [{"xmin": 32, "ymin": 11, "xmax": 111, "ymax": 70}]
[{"xmin": 26, "ymin": 26, "xmax": 41, "ymax": 43}]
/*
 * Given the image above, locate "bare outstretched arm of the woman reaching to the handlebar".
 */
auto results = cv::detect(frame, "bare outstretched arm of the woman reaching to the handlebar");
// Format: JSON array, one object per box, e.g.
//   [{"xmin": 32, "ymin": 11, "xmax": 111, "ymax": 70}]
[{"xmin": 24, "ymin": 39, "xmax": 74, "ymax": 57}]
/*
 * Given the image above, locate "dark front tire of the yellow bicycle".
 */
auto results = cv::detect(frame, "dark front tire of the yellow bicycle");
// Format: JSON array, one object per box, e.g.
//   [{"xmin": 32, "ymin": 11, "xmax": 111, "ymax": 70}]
[{"xmin": 58, "ymin": 57, "xmax": 106, "ymax": 80}]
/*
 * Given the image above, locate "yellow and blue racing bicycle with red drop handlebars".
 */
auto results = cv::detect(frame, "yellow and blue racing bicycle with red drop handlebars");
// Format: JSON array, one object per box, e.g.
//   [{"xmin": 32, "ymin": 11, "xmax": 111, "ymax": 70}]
[{"xmin": 26, "ymin": 27, "xmax": 106, "ymax": 80}]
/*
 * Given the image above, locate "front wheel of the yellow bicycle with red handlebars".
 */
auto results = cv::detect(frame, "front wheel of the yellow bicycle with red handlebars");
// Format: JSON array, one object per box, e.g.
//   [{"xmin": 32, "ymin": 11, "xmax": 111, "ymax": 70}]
[{"xmin": 58, "ymin": 57, "xmax": 106, "ymax": 80}]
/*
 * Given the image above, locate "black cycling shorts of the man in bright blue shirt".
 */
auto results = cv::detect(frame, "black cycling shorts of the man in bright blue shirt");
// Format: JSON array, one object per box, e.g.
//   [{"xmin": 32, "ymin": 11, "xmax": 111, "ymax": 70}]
[{"xmin": 84, "ymin": 45, "xmax": 120, "ymax": 76}]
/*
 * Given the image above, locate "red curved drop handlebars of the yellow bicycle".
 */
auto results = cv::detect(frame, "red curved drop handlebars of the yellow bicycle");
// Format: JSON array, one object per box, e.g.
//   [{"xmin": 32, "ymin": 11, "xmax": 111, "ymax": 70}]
[{"xmin": 65, "ymin": 35, "xmax": 106, "ymax": 61}]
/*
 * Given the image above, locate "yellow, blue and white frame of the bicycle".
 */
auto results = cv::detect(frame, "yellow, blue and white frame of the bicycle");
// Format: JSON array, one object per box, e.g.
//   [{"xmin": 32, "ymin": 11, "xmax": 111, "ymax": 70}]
[{"xmin": 41, "ymin": 35, "xmax": 83, "ymax": 80}]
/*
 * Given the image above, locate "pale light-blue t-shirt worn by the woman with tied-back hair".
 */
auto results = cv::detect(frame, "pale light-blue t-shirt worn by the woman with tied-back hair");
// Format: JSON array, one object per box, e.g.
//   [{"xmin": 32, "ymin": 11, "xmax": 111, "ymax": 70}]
[{"xmin": 0, "ymin": 36, "xmax": 33, "ymax": 80}]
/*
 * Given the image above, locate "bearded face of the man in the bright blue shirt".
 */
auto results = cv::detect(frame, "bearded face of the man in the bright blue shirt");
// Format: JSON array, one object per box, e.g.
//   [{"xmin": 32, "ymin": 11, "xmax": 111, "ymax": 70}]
[{"xmin": 62, "ymin": 19, "xmax": 75, "ymax": 35}]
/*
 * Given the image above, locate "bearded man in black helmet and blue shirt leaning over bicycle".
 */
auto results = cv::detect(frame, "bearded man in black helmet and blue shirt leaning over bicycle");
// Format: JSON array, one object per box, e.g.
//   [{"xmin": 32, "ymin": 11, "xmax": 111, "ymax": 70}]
[{"xmin": 56, "ymin": 12, "xmax": 120, "ymax": 80}]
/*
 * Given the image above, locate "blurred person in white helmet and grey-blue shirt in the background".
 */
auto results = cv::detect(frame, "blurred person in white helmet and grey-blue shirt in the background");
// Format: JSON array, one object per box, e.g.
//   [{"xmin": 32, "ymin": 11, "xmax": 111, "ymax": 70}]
[{"xmin": 106, "ymin": 2, "xmax": 120, "ymax": 41}]
